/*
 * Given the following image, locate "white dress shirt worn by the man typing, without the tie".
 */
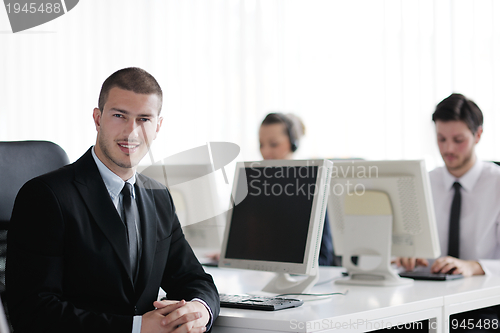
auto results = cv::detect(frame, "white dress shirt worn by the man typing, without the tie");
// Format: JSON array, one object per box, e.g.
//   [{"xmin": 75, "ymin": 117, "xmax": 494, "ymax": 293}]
[{"xmin": 429, "ymin": 161, "xmax": 500, "ymax": 275}]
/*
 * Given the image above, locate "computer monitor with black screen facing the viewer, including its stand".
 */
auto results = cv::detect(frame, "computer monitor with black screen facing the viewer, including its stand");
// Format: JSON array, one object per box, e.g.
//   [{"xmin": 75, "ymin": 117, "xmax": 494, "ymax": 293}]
[{"xmin": 219, "ymin": 160, "xmax": 332, "ymax": 294}]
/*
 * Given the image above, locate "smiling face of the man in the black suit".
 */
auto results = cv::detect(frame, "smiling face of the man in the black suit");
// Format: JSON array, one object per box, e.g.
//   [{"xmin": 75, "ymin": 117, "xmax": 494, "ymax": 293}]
[{"xmin": 94, "ymin": 87, "xmax": 163, "ymax": 178}]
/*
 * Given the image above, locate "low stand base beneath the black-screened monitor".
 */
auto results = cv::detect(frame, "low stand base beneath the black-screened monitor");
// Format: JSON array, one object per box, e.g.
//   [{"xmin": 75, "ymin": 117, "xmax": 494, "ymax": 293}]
[{"xmin": 262, "ymin": 269, "xmax": 319, "ymax": 295}]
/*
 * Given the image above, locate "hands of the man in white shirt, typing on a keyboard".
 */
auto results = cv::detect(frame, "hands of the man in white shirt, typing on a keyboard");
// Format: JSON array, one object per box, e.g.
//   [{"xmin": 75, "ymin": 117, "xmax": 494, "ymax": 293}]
[{"xmin": 394, "ymin": 256, "xmax": 484, "ymax": 277}]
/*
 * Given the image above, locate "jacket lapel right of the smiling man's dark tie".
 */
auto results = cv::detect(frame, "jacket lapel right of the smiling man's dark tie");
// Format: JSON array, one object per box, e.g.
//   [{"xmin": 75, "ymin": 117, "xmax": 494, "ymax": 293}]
[{"xmin": 135, "ymin": 174, "xmax": 158, "ymax": 297}]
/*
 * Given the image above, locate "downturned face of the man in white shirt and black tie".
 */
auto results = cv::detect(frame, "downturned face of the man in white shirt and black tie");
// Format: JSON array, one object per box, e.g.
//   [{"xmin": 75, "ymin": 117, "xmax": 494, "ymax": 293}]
[{"xmin": 436, "ymin": 120, "xmax": 483, "ymax": 171}]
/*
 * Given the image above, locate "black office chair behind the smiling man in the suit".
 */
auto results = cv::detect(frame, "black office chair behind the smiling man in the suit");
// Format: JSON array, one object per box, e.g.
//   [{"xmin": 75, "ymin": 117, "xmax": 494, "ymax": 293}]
[{"xmin": 0, "ymin": 141, "xmax": 69, "ymax": 294}]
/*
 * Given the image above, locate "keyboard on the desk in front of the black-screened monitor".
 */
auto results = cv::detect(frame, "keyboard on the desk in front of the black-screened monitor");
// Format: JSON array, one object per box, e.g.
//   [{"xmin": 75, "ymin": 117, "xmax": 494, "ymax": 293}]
[{"xmin": 219, "ymin": 294, "xmax": 304, "ymax": 311}]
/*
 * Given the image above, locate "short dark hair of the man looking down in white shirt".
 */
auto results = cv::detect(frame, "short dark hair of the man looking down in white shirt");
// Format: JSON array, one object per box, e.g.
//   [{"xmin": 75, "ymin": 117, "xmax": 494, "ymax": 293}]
[{"xmin": 432, "ymin": 93, "xmax": 483, "ymax": 134}]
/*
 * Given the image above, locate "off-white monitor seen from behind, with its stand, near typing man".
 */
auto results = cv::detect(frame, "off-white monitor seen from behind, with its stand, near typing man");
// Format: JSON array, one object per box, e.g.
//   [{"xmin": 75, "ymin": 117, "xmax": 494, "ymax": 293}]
[{"xmin": 328, "ymin": 161, "xmax": 440, "ymax": 286}]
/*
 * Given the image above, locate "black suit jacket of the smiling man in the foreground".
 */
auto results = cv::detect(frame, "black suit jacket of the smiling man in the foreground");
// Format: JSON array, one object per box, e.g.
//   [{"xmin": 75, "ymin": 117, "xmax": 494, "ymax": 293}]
[{"xmin": 6, "ymin": 149, "xmax": 219, "ymax": 333}]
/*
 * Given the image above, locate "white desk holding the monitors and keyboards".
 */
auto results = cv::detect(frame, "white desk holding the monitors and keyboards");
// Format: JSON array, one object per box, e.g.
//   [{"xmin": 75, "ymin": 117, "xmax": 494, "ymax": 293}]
[{"xmin": 207, "ymin": 268, "xmax": 500, "ymax": 333}]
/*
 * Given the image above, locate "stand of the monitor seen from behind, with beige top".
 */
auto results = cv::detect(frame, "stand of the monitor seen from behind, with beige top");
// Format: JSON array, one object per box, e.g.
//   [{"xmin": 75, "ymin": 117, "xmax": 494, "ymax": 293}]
[{"xmin": 335, "ymin": 191, "xmax": 413, "ymax": 286}]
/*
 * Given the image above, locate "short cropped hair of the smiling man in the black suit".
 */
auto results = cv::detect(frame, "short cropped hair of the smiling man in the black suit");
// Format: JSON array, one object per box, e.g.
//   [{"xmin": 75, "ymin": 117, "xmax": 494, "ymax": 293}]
[{"xmin": 98, "ymin": 67, "xmax": 163, "ymax": 114}]
